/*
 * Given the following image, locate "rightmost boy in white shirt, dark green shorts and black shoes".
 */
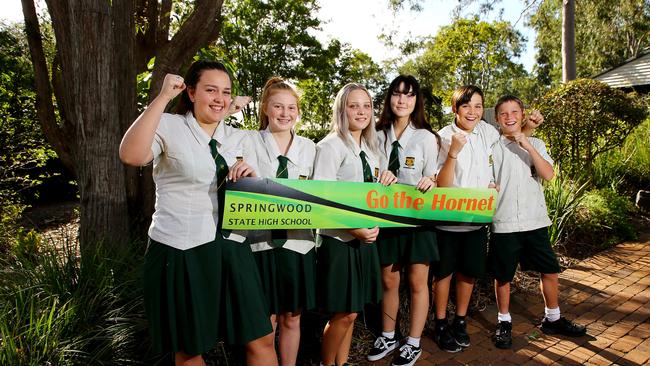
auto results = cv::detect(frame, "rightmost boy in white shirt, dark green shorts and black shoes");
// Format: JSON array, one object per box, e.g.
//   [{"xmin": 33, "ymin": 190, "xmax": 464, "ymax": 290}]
[{"xmin": 488, "ymin": 95, "xmax": 586, "ymax": 348}]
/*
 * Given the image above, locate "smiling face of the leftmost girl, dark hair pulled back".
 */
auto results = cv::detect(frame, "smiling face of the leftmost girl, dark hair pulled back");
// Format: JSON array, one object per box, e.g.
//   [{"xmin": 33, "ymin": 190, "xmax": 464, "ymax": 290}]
[{"xmin": 187, "ymin": 69, "xmax": 232, "ymax": 125}]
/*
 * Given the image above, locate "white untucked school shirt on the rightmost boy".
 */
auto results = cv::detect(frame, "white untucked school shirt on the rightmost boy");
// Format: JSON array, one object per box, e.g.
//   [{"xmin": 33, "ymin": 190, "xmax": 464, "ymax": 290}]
[{"xmin": 492, "ymin": 136, "xmax": 553, "ymax": 233}]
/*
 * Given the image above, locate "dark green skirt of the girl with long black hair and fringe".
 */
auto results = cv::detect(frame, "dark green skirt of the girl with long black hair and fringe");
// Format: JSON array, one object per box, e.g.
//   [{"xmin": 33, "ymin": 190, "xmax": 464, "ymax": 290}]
[{"xmin": 377, "ymin": 227, "xmax": 440, "ymax": 265}]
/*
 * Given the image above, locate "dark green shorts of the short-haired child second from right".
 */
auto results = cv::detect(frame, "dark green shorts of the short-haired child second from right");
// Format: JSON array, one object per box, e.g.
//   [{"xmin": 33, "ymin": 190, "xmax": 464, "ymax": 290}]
[{"xmin": 432, "ymin": 226, "xmax": 487, "ymax": 278}]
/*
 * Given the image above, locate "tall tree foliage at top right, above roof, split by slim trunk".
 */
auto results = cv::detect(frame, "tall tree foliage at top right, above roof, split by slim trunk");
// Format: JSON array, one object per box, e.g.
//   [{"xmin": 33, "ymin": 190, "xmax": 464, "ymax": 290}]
[{"xmin": 529, "ymin": 0, "xmax": 650, "ymax": 85}]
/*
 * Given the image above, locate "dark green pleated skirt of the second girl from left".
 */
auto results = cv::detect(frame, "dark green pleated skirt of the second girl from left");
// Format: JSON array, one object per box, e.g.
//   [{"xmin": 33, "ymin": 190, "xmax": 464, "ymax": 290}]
[{"xmin": 253, "ymin": 244, "xmax": 316, "ymax": 314}]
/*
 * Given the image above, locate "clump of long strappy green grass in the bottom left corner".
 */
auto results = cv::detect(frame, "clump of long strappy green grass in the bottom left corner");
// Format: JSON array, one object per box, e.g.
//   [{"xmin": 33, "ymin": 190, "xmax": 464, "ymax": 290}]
[{"xmin": 0, "ymin": 239, "xmax": 152, "ymax": 365}]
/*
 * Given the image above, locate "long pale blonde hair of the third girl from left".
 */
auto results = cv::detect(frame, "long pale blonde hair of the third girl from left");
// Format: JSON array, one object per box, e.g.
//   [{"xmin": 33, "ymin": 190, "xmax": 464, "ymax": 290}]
[{"xmin": 331, "ymin": 83, "xmax": 379, "ymax": 154}]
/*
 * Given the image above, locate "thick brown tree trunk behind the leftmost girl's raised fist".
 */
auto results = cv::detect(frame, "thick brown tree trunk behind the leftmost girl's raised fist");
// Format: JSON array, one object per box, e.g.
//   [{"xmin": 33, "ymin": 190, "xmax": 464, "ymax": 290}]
[{"xmin": 47, "ymin": 0, "xmax": 134, "ymax": 253}]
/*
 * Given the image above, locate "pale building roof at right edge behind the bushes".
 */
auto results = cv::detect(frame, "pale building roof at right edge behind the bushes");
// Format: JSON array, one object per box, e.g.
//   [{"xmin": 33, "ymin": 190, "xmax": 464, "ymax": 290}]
[{"xmin": 593, "ymin": 50, "xmax": 650, "ymax": 88}]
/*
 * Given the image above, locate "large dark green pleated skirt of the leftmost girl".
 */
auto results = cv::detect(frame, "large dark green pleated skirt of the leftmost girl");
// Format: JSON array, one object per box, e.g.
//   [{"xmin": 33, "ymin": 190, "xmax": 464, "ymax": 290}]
[{"xmin": 143, "ymin": 236, "xmax": 272, "ymax": 355}]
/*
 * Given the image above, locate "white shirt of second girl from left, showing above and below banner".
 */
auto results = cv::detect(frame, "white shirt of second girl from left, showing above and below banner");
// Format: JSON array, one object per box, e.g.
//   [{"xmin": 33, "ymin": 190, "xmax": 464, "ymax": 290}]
[{"xmin": 248, "ymin": 128, "xmax": 316, "ymax": 254}]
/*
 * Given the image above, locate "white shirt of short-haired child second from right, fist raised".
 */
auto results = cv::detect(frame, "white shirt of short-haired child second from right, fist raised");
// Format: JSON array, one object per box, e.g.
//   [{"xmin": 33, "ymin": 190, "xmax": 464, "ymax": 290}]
[{"xmin": 437, "ymin": 121, "xmax": 499, "ymax": 232}]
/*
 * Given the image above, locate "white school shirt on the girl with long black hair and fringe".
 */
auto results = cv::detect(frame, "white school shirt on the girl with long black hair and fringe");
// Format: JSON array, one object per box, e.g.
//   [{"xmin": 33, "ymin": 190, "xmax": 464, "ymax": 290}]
[{"xmin": 377, "ymin": 123, "xmax": 438, "ymax": 186}]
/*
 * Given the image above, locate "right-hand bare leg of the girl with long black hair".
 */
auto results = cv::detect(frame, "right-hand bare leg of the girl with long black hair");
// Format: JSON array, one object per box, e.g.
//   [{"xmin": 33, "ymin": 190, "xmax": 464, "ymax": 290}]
[{"xmin": 409, "ymin": 263, "xmax": 429, "ymax": 338}]
